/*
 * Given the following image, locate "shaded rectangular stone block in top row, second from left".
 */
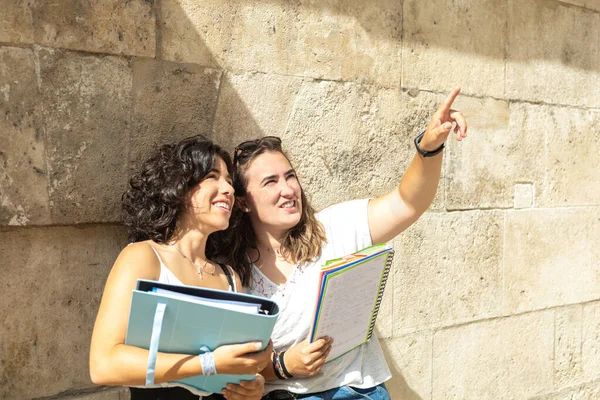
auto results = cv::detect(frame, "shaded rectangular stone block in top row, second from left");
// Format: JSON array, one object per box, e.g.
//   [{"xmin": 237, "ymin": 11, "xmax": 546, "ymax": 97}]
[{"xmin": 31, "ymin": 0, "xmax": 156, "ymax": 57}]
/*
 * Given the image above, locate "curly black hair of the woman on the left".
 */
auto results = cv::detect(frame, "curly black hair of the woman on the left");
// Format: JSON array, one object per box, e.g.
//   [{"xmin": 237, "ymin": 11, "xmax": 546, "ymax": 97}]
[{"xmin": 122, "ymin": 135, "xmax": 233, "ymax": 247}]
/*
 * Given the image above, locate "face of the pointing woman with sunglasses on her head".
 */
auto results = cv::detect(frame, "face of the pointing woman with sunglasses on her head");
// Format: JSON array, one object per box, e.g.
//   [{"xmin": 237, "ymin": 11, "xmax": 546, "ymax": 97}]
[{"xmin": 242, "ymin": 151, "xmax": 302, "ymax": 235}]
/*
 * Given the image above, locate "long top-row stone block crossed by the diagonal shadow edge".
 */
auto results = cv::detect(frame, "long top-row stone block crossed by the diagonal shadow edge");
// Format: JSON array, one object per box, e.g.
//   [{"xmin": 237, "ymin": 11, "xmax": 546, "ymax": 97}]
[{"xmin": 161, "ymin": 0, "xmax": 402, "ymax": 87}]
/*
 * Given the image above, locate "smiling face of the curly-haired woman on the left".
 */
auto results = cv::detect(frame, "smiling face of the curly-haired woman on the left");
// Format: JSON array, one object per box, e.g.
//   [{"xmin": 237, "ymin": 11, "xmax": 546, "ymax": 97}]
[{"xmin": 184, "ymin": 157, "xmax": 234, "ymax": 233}]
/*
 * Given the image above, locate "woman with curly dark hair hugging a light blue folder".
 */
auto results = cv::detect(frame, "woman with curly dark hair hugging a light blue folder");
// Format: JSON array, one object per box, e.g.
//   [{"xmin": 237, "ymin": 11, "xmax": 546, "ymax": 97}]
[{"xmin": 90, "ymin": 136, "xmax": 271, "ymax": 400}]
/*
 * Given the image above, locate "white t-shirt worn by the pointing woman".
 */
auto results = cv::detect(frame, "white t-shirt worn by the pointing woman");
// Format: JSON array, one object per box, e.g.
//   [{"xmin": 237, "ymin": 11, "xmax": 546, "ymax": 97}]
[{"xmin": 247, "ymin": 199, "xmax": 392, "ymax": 393}]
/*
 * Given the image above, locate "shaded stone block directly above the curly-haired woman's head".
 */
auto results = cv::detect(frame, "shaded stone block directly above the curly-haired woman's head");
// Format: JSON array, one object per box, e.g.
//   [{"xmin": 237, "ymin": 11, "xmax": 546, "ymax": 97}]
[{"xmin": 131, "ymin": 59, "xmax": 221, "ymax": 169}]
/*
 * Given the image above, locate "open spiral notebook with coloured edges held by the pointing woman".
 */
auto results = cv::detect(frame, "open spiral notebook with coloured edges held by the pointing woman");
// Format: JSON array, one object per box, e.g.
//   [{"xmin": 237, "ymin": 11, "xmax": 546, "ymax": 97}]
[{"xmin": 309, "ymin": 244, "xmax": 394, "ymax": 361}]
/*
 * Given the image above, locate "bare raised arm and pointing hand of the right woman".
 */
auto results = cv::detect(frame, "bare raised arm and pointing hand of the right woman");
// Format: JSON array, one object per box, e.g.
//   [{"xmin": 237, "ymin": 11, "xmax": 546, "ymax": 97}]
[{"xmin": 368, "ymin": 88, "xmax": 467, "ymax": 243}]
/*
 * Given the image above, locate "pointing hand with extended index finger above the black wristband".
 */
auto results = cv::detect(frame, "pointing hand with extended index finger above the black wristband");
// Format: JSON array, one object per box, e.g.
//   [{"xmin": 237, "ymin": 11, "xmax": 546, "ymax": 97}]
[{"xmin": 419, "ymin": 88, "xmax": 467, "ymax": 151}]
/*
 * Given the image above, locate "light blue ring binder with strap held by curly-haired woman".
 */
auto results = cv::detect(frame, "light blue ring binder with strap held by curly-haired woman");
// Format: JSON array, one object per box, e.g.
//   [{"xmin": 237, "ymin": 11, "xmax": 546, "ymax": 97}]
[{"xmin": 125, "ymin": 279, "xmax": 279, "ymax": 393}]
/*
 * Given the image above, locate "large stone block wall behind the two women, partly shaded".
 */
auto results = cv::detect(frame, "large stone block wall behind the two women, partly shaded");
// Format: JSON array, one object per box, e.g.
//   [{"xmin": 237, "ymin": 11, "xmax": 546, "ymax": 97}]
[{"xmin": 0, "ymin": 0, "xmax": 600, "ymax": 400}]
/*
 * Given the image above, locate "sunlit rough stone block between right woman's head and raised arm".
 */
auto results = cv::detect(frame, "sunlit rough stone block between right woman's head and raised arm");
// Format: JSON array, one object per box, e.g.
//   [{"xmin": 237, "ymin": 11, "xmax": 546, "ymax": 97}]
[{"xmin": 282, "ymin": 81, "xmax": 443, "ymax": 209}]
